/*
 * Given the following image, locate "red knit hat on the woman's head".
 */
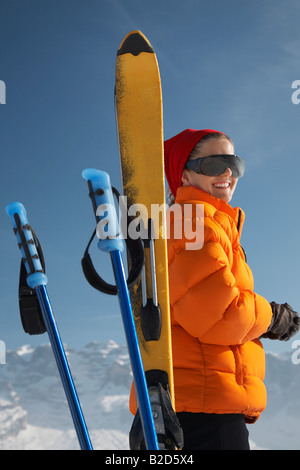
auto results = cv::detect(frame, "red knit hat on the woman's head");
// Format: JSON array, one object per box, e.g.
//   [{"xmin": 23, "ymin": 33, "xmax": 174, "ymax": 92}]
[{"xmin": 164, "ymin": 129, "xmax": 223, "ymax": 196}]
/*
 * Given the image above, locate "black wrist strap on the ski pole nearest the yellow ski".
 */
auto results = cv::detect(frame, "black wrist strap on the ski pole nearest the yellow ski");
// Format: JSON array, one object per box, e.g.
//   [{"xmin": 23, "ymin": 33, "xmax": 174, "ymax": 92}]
[{"xmin": 81, "ymin": 170, "xmax": 144, "ymax": 295}]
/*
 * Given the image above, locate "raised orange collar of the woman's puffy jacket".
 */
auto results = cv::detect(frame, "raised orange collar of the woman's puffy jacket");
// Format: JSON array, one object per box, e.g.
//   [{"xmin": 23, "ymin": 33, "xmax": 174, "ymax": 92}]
[{"xmin": 175, "ymin": 185, "xmax": 245, "ymax": 234}]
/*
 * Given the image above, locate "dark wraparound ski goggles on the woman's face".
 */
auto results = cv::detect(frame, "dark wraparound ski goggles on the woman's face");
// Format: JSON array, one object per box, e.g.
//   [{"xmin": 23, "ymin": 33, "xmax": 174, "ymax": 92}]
[{"xmin": 185, "ymin": 154, "xmax": 245, "ymax": 178}]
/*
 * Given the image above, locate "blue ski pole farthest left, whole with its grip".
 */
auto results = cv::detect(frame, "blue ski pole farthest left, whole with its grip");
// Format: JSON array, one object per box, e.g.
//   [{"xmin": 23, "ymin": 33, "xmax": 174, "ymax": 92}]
[{"xmin": 6, "ymin": 202, "xmax": 93, "ymax": 450}]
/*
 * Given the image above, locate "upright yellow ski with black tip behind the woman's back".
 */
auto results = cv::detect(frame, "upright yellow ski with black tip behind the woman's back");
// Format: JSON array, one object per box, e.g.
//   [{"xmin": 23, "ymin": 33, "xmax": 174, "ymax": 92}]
[{"xmin": 115, "ymin": 31, "xmax": 181, "ymax": 449}]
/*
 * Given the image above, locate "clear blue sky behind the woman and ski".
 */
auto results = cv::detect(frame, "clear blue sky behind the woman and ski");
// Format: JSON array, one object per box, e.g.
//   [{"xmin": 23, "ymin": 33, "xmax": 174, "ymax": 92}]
[{"xmin": 0, "ymin": 0, "xmax": 300, "ymax": 351}]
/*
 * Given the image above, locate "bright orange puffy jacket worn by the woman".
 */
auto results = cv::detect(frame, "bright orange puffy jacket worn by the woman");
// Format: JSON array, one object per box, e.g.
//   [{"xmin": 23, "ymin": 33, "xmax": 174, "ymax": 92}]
[{"xmin": 168, "ymin": 186, "xmax": 272, "ymax": 423}]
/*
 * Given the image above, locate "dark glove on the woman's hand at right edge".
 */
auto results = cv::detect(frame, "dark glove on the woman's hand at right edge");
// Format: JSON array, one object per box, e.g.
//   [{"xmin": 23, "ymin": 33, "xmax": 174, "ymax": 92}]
[{"xmin": 261, "ymin": 302, "xmax": 300, "ymax": 341}]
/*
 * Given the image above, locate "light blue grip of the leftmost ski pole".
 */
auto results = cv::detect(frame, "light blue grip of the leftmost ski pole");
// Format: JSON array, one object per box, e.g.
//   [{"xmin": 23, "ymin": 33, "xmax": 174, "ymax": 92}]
[{"xmin": 6, "ymin": 202, "xmax": 48, "ymax": 289}]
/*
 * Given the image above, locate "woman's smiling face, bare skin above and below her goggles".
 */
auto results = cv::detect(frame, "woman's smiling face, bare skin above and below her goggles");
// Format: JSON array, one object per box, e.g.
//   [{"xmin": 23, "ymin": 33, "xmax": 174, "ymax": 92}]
[{"xmin": 181, "ymin": 139, "xmax": 238, "ymax": 202}]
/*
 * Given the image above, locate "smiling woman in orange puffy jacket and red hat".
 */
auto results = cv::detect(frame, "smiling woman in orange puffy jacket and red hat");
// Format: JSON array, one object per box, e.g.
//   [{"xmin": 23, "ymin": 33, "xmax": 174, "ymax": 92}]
[{"xmin": 165, "ymin": 129, "xmax": 299, "ymax": 450}]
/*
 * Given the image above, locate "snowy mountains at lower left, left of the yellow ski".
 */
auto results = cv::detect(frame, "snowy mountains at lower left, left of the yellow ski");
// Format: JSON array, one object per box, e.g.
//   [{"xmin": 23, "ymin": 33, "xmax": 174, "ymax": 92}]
[{"xmin": 0, "ymin": 341, "xmax": 132, "ymax": 450}]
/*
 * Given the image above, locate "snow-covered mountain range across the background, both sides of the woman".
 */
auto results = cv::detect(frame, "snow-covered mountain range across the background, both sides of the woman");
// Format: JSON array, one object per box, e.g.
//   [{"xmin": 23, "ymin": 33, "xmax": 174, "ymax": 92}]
[{"xmin": 0, "ymin": 341, "xmax": 300, "ymax": 450}]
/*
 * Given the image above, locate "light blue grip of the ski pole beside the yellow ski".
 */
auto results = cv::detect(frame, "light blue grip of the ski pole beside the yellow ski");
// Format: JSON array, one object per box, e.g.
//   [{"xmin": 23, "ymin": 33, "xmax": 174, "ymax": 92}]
[{"xmin": 82, "ymin": 168, "xmax": 124, "ymax": 252}]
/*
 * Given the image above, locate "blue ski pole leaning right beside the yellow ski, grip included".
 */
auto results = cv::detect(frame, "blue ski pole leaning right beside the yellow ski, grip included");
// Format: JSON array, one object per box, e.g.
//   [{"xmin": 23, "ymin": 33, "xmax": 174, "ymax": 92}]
[{"xmin": 82, "ymin": 168, "xmax": 159, "ymax": 450}]
